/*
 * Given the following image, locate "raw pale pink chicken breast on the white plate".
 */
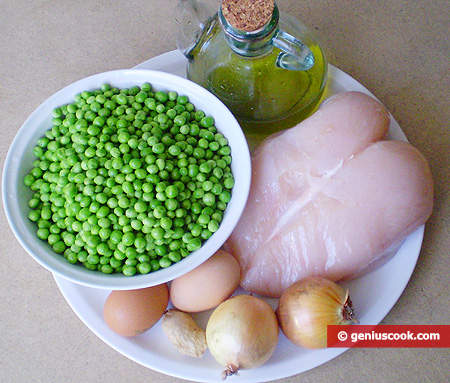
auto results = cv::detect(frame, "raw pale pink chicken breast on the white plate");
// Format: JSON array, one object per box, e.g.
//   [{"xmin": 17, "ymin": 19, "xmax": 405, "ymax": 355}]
[{"xmin": 226, "ymin": 92, "xmax": 433, "ymax": 297}]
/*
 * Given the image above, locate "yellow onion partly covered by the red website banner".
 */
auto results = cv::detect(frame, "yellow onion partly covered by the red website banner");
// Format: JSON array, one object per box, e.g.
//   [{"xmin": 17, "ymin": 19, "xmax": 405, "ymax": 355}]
[{"xmin": 276, "ymin": 277, "xmax": 358, "ymax": 349}]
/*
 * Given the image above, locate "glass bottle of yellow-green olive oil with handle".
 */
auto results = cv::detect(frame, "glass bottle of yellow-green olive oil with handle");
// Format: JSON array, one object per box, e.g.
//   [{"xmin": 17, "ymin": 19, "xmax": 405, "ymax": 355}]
[{"xmin": 176, "ymin": 0, "xmax": 327, "ymax": 136}]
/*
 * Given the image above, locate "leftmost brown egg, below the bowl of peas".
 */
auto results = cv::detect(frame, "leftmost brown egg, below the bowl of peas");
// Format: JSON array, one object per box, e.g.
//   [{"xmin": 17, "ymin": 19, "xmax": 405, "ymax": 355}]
[{"xmin": 103, "ymin": 283, "xmax": 169, "ymax": 337}]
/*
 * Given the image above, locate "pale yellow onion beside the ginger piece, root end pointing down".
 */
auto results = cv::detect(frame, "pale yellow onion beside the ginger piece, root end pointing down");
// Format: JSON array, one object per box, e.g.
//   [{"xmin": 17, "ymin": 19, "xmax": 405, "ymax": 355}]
[{"xmin": 206, "ymin": 295, "xmax": 279, "ymax": 378}]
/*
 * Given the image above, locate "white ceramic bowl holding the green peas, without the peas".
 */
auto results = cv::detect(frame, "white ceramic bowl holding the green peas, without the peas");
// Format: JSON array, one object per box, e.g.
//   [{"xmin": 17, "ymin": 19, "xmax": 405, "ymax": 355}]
[{"xmin": 2, "ymin": 69, "xmax": 251, "ymax": 290}]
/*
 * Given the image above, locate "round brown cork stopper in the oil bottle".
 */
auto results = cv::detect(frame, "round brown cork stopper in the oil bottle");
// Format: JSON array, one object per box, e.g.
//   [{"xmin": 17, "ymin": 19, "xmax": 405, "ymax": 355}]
[{"xmin": 222, "ymin": 0, "xmax": 274, "ymax": 32}]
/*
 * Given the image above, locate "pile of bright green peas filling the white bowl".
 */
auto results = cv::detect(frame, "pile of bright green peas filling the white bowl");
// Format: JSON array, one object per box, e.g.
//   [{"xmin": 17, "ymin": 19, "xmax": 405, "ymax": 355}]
[{"xmin": 24, "ymin": 83, "xmax": 234, "ymax": 276}]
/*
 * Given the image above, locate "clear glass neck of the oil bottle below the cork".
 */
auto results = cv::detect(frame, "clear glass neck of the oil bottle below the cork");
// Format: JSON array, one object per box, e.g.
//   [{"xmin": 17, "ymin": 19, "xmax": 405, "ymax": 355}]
[{"xmin": 218, "ymin": 4, "xmax": 279, "ymax": 57}]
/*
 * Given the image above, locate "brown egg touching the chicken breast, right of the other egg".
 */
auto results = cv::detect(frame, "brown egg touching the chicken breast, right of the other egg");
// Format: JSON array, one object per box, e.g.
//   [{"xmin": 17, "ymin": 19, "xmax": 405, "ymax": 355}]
[{"xmin": 170, "ymin": 250, "xmax": 240, "ymax": 312}]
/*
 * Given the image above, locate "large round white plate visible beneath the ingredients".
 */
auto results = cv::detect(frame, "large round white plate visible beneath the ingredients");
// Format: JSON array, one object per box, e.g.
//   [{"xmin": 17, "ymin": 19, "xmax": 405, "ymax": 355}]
[{"xmin": 55, "ymin": 51, "xmax": 424, "ymax": 383}]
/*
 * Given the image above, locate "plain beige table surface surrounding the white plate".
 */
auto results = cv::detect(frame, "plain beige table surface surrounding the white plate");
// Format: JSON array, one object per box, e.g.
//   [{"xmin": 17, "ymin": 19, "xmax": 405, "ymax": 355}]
[{"xmin": 0, "ymin": 0, "xmax": 450, "ymax": 383}]
